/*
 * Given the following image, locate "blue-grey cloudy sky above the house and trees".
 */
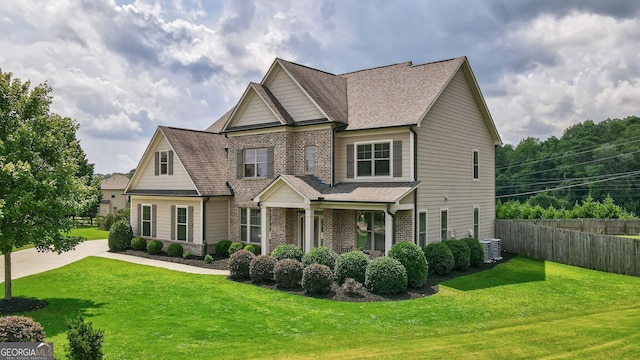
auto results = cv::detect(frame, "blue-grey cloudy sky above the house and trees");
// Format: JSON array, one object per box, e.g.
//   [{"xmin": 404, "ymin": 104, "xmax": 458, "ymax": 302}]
[{"xmin": 0, "ymin": 0, "xmax": 640, "ymax": 173}]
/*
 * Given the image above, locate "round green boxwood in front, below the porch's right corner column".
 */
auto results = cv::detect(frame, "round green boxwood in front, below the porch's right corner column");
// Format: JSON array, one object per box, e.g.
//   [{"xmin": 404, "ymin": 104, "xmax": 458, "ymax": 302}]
[{"xmin": 364, "ymin": 256, "xmax": 407, "ymax": 294}]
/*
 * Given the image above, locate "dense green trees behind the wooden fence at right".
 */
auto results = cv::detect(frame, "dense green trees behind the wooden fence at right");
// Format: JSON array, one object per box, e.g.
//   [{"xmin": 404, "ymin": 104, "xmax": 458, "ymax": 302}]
[{"xmin": 496, "ymin": 116, "xmax": 640, "ymax": 213}]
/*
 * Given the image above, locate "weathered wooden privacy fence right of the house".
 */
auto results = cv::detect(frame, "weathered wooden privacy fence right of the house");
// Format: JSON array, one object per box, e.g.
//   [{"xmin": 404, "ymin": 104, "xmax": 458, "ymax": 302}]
[{"xmin": 495, "ymin": 220, "xmax": 640, "ymax": 276}]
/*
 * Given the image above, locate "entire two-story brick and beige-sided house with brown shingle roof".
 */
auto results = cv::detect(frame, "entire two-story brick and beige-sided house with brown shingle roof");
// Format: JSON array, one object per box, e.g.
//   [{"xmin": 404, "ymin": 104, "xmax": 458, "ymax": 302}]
[{"xmin": 125, "ymin": 57, "xmax": 501, "ymax": 254}]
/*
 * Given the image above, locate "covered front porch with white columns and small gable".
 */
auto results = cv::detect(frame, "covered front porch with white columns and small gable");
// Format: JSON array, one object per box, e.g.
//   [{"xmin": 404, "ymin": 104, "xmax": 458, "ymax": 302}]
[{"xmin": 254, "ymin": 175, "xmax": 417, "ymax": 256}]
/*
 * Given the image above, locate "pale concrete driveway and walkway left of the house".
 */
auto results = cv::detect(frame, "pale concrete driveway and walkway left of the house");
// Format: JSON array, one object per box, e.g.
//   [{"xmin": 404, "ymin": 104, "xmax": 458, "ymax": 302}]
[{"xmin": 0, "ymin": 240, "xmax": 229, "ymax": 282}]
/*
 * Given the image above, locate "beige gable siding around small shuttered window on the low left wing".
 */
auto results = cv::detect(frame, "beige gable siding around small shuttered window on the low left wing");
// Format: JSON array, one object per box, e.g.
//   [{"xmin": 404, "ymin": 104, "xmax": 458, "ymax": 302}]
[{"xmin": 129, "ymin": 135, "xmax": 195, "ymax": 190}]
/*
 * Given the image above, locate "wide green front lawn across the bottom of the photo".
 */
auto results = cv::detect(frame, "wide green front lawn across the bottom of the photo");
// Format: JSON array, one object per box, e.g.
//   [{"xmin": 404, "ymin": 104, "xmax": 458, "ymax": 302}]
[{"xmin": 6, "ymin": 257, "xmax": 640, "ymax": 359}]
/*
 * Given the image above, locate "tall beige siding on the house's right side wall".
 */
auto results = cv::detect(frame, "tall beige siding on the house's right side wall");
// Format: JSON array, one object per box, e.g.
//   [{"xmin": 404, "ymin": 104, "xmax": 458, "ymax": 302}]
[{"xmin": 416, "ymin": 71, "xmax": 495, "ymax": 242}]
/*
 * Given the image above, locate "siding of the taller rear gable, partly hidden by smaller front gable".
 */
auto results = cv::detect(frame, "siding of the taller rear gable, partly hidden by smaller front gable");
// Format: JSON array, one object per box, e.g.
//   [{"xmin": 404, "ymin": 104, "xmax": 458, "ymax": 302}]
[{"xmin": 266, "ymin": 69, "xmax": 324, "ymax": 121}]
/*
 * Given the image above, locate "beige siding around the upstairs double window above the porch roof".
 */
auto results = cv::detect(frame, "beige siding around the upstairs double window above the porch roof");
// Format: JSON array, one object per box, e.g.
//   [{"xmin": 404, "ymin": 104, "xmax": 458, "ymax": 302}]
[{"xmin": 334, "ymin": 128, "xmax": 413, "ymax": 183}]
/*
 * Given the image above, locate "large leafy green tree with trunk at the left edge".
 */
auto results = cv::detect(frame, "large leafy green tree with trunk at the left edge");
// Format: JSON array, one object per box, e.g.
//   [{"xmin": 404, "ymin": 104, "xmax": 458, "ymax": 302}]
[{"xmin": 0, "ymin": 71, "xmax": 96, "ymax": 300}]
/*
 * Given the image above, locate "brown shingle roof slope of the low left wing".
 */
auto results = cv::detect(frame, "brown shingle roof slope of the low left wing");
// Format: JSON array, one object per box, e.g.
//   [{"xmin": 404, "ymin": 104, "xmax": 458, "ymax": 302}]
[{"xmin": 160, "ymin": 126, "xmax": 231, "ymax": 196}]
